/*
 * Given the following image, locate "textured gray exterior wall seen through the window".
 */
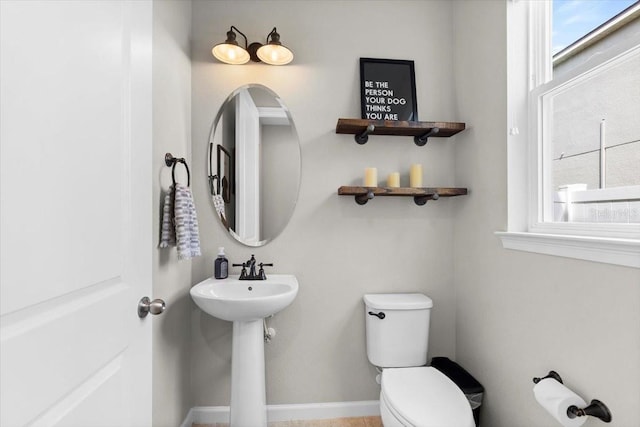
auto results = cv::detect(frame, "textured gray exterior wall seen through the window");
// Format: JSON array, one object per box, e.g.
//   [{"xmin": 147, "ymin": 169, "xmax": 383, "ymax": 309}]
[{"xmin": 551, "ymin": 41, "xmax": 640, "ymax": 189}]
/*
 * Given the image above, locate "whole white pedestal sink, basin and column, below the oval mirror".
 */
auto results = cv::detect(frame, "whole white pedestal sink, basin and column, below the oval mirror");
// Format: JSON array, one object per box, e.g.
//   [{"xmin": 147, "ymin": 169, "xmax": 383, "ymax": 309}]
[{"xmin": 191, "ymin": 274, "xmax": 298, "ymax": 427}]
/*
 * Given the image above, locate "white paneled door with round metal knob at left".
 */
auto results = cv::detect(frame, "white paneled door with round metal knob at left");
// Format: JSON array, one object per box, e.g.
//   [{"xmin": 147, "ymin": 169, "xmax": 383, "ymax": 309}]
[{"xmin": 0, "ymin": 0, "xmax": 152, "ymax": 427}]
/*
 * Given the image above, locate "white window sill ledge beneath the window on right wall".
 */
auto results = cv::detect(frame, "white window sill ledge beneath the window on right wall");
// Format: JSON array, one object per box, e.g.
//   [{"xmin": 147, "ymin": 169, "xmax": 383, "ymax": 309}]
[{"xmin": 495, "ymin": 231, "xmax": 640, "ymax": 268}]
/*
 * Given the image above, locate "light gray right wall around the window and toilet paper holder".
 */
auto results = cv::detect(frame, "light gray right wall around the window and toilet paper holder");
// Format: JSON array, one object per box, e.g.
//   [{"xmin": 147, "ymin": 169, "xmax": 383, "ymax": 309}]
[{"xmin": 453, "ymin": 1, "xmax": 640, "ymax": 427}]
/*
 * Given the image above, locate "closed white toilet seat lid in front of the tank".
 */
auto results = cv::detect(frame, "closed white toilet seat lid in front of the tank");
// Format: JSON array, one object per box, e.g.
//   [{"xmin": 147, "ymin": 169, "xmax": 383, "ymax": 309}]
[{"xmin": 380, "ymin": 366, "xmax": 475, "ymax": 427}]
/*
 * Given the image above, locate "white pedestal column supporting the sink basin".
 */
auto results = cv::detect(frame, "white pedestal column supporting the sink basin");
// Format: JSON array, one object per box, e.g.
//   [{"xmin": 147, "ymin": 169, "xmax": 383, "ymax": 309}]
[{"xmin": 229, "ymin": 319, "xmax": 267, "ymax": 427}]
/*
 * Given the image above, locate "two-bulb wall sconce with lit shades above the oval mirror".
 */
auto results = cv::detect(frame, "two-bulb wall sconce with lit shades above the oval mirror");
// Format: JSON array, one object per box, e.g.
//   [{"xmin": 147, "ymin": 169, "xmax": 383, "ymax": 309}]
[{"xmin": 211, "ymin": 25, "xmax": 293, "ymax": 65}]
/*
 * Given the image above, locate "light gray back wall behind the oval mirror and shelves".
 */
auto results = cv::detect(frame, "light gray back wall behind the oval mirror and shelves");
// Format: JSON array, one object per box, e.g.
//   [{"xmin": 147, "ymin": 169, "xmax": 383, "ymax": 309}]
[{"xmin": 191, "ymin": 1, "xmax": 460, "ymax": 405}]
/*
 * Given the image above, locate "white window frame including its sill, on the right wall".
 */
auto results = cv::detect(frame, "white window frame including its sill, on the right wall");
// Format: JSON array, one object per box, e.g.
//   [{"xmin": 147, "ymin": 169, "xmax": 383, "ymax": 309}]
[{"xmin": 496, "ymin": 1, "xmax": 640, "ymax": 268}]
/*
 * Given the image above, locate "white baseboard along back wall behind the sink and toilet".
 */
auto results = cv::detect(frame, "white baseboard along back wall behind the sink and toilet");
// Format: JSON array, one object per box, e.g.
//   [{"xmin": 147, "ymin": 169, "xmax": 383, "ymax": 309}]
[{"xmin": 180, "ymin": 400, "xmax": 380, "ymax": 427}]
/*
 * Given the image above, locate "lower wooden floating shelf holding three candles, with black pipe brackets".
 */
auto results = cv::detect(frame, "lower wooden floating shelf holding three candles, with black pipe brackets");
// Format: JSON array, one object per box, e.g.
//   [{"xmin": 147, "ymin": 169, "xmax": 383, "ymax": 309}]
[{"xmin": 338, "ymin": 186, "xmax": 468, "ymax": 206}]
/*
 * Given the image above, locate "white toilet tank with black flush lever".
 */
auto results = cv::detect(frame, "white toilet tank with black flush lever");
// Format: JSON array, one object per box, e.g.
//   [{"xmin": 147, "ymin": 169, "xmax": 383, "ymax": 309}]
[{"xmin": 363, "ymin": 293, "xmax": 433, "ymax": 368}]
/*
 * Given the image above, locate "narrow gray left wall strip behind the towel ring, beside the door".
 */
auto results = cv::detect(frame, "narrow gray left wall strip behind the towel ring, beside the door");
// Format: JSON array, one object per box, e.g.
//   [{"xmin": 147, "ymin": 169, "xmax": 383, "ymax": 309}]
[{"xmin": 150, "ymin": 0, "xmax": 192, "ymax": 427}]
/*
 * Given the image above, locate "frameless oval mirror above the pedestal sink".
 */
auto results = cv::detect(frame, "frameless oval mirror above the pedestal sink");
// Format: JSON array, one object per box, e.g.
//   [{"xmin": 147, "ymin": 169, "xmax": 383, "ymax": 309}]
[{"xmin": 208, "ymin": 84, "xmax": 300, "ymax": 246}]
